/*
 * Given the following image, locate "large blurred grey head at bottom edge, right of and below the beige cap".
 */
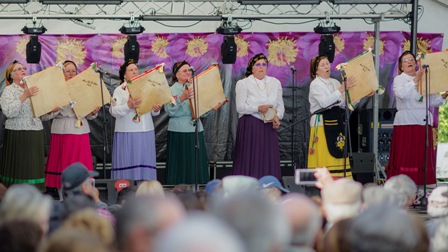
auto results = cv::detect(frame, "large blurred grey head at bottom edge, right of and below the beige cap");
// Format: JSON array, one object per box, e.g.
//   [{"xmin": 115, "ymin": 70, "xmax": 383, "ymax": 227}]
[{"xmin": 347, "ymin": 205, "xmax": 421, "ymax": 252}]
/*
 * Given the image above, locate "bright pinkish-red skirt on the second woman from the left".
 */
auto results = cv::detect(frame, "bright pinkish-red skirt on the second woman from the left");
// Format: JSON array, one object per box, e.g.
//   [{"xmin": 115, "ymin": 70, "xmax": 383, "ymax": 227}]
[{"xmin": 45, "ymin": 134, "xmax": 93, "ymax": 188}]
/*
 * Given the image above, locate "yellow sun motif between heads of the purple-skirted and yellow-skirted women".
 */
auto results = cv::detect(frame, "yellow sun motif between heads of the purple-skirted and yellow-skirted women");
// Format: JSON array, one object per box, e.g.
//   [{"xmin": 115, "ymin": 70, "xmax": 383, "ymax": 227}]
[{"xmin": 268, "ymin": 37, "xmax": 299, "ymax": 66}]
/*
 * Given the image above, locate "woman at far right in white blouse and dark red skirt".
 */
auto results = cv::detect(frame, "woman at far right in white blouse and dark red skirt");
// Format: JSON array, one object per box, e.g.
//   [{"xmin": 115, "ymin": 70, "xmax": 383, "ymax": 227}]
[{"xmin": 387, "ymin": 51, "xmax": 448, "ymax": 188}]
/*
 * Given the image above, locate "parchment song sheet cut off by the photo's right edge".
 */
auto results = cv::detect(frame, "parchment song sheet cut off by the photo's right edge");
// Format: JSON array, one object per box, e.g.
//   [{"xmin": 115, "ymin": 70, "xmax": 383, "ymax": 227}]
[{"xmin": 419, "ymin": 51, "xmax": 448, "ymax": 95}]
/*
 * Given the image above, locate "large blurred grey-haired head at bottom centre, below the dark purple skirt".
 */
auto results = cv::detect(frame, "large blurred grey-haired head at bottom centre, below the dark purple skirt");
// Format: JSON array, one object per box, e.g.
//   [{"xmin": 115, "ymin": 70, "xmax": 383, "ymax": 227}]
[{"xmin": 212, "ymin": 191, "xmax": 291, "ymax": 252}]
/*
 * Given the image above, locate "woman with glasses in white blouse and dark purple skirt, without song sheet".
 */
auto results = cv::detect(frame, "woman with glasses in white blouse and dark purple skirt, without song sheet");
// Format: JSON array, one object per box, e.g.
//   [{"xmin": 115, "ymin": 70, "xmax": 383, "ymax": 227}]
[{"xmin": 233, "ymin": 53, "xmax": 285, "ymax": 179}]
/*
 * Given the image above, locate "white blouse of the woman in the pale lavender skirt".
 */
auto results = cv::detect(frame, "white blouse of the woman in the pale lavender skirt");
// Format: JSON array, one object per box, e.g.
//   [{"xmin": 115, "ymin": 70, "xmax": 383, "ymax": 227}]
[{"xmin": 109, "ymin": 83, "xmax": 160, "ymax": 132}]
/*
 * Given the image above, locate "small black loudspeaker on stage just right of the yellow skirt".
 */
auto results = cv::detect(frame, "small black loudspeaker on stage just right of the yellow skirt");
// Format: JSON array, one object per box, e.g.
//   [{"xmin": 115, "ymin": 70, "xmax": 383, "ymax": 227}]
[{"xmin": 350, "ymin": 152, "xmax": 375, "ymax": 184}]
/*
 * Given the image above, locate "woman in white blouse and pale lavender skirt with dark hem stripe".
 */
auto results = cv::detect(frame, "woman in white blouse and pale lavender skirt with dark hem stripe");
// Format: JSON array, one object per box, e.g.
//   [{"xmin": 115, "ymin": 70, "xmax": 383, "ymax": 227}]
[{"xmin": 110, "ymin": 60, "xmax": 162, "ymax": 181}]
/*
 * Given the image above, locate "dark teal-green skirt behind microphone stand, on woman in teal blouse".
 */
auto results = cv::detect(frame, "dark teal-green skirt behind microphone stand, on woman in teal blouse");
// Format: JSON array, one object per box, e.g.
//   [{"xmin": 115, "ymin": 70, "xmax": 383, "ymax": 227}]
[{"xmin": 166, "ymin": 131, "xmax": 210, "ymax": 185}]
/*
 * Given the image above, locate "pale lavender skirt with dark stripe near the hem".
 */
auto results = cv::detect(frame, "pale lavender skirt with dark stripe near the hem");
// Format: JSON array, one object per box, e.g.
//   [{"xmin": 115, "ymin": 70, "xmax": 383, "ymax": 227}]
[{"xmin": 112, "ymin": 130, "xmax": 157, "ymax": 181}]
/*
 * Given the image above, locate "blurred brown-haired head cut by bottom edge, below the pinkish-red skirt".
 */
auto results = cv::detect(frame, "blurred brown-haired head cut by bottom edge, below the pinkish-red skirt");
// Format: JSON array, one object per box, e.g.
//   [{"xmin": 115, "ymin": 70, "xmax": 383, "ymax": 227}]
[{"xmin": 39, "ymin": 228, "xmax": 109, "ymax": 252}]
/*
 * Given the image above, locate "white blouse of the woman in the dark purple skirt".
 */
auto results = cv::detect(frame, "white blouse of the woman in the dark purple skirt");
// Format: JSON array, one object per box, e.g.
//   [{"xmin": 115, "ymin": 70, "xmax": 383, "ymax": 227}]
[{"xmin": 235, "ymin": 75, "xmax": 285, "ymax": 120}]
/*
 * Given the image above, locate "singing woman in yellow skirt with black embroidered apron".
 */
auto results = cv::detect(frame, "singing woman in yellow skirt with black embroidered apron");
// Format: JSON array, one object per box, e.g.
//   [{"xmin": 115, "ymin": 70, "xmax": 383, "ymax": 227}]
[{"xmin": 308, "ymin": 56, "xmax": 354, "ymax": 177}]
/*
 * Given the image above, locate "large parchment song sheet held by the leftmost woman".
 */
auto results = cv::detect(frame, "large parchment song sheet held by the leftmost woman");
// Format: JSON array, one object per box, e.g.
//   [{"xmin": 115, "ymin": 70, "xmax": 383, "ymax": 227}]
[{"xmin": 26, "ymin": 66, "xmax": 70, "ymax": 117}]
